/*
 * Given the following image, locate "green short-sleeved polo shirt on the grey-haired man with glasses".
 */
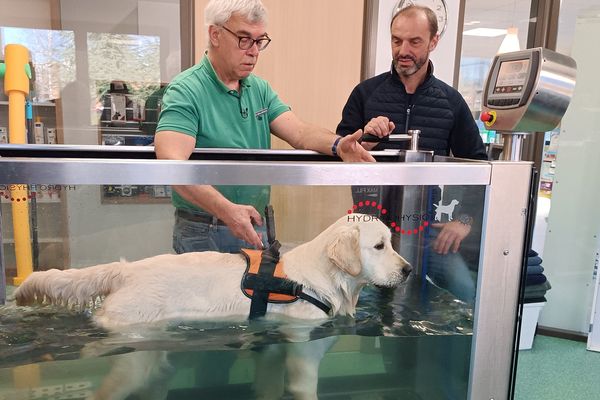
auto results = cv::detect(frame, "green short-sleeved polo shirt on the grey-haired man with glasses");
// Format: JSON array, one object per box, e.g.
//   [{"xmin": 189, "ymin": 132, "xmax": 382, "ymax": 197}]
[{"xmin": 156, "ymin": 55, "xmax": 290, "ymax": 214}]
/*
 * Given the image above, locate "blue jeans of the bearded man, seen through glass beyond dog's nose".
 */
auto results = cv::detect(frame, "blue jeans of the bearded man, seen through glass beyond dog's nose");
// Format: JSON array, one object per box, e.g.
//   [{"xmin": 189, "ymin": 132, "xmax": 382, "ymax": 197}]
[{"xmin": 425, "ymin": 230, "xmax": 477, "ymax": 304}]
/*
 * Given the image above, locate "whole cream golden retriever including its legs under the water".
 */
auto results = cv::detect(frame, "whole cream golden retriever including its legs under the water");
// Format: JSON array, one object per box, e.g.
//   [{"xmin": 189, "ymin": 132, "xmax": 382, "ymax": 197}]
[{"xmin": 15, "ymin": 214, "xmax": 411, "ymax": 399}]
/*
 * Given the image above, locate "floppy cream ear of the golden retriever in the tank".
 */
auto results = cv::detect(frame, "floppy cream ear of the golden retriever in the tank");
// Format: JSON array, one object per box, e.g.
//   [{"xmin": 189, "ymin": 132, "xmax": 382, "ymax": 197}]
[{"xmin": 327, "ymin": 226, "xmax": 362, "ymax": 276}]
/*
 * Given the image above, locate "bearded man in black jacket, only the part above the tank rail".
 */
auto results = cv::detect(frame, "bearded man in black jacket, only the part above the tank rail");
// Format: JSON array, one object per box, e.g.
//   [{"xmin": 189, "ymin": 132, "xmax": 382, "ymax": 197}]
[{"xmin": 337, "ymin": 6, "xmax": 487, "ymax": 160}]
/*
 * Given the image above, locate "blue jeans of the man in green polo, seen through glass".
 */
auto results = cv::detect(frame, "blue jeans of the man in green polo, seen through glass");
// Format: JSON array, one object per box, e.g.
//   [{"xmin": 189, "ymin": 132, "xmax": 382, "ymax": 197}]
[{"xmin": 173, "ymin": 209, "xmax": 267, "ymax": 254}]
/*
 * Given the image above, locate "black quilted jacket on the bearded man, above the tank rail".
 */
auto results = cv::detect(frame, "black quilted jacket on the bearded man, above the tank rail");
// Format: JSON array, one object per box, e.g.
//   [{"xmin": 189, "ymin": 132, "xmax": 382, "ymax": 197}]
[{"xmin": 337, "ymin": 62, "xmax": 487, "ymax": 160}]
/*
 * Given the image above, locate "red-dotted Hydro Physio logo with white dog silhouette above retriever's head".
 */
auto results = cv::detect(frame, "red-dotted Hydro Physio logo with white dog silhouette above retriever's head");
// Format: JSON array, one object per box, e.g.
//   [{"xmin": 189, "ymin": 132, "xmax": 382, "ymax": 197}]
[{"xmin": 348, "ymin": 199, "xmax": 459, "ymax": 236}]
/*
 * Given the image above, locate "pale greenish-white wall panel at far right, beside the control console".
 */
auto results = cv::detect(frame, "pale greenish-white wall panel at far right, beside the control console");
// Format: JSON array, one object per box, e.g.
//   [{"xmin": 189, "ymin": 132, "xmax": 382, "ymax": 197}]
[{"xmin": 539, "ymin": 12, "xmax": 600, "ymax": 334}]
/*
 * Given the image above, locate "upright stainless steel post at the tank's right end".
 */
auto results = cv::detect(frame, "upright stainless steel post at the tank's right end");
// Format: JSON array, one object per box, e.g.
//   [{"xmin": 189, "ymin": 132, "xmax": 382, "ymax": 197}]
[{"xmin": 469, "ymin": 161, "xmax": 532, "ymax": 400}]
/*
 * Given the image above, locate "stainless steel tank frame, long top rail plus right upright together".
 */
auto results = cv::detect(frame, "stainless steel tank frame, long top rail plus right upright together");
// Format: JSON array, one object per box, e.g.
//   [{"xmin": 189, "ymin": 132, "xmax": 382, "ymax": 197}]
[{"xmin": 0, "ymin": 148, "xmax": 531, "ymax": 400}]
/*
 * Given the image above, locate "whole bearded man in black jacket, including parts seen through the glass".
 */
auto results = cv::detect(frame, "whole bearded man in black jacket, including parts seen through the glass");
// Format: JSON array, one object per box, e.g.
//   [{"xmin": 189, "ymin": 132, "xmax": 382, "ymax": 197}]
[{"xmin": 337, "ymin": 5, "xmax": 487, "ymax": 301}]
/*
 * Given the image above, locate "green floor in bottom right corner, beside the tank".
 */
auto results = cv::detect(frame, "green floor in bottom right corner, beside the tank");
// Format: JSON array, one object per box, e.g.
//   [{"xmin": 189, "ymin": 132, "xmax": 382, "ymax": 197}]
[{"xmin": 515, "ymin": 335, "xmax": 600, "ymax": 400}]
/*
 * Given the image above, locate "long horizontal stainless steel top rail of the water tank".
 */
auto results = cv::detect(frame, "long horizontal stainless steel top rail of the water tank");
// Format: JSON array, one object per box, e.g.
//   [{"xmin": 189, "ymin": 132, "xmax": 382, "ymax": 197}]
[{"xmin": 0, "ymin": 158, "xmax": 491, "ymax": 185}]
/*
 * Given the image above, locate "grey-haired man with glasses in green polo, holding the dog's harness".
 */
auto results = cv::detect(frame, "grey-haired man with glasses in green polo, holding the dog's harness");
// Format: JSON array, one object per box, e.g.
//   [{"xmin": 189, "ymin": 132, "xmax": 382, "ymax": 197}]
[{"xmin": 155, "ymin": 0, "xmax": 374, "ymax": 253}]
